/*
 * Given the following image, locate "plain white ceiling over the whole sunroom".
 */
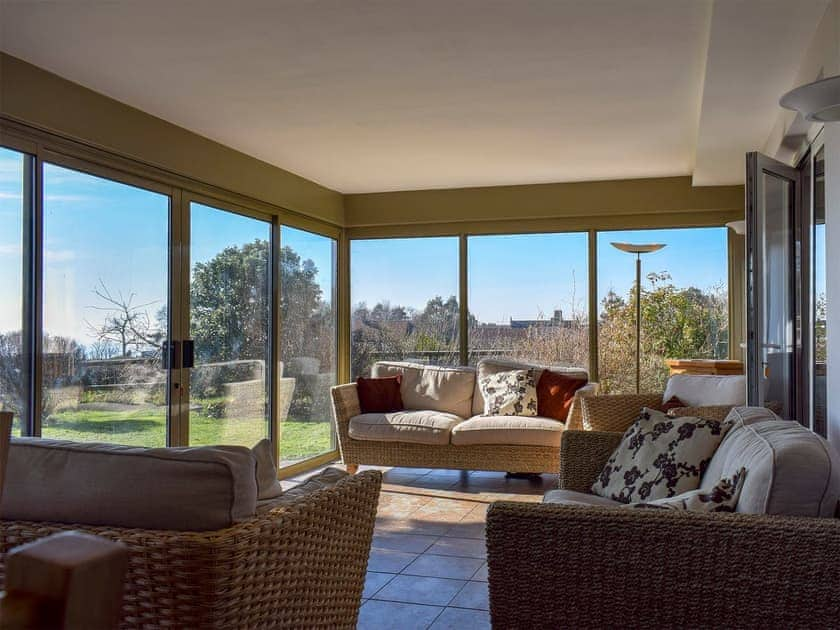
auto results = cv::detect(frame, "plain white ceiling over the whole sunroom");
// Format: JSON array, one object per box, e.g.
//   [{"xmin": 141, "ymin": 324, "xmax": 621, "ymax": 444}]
[{"xmin": 0, "ymin": 0, "xmax": 827, "ymax": 193}]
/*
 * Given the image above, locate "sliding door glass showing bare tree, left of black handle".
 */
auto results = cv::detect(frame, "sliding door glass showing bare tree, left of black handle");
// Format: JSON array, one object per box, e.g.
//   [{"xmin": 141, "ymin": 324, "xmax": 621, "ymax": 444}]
[{"xmin": 42, "ymin": 164, "xmax": 169, "ymax": 446}]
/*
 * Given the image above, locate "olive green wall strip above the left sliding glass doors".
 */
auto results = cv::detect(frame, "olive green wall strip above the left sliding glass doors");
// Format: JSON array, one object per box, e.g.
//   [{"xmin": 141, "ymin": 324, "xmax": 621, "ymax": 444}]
[{"xmin": 0, "ymin": 53, "xmax": 344, "ymax": 226}]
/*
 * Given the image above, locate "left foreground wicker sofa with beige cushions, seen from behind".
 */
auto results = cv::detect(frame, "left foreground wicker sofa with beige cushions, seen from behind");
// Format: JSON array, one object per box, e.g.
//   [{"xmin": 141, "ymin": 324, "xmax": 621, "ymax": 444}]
[{"xmin": 0, "ymin": 440, "xmax": 381, "ymax": 629}]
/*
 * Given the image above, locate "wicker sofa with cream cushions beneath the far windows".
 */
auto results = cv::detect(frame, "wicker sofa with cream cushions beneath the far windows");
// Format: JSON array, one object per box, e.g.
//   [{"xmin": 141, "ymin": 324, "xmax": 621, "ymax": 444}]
[{"xmin": 332, "ymin": 359, "xmax": 598, "ymax": 473}]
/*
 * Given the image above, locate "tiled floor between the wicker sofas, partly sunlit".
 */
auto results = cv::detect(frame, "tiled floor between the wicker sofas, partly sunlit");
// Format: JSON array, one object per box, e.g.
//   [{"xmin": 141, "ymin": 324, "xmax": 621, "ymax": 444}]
[{"xmin": 286, "ymin": 468, "xmax": 557, "ymax": 630}]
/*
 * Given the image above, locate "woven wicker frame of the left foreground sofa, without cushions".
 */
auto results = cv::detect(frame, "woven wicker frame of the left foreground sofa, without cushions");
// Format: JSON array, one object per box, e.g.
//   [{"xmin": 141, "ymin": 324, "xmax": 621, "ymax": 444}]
[{"xmin": 0, "ymin": 471, "xmax": 382, "ymax": 629}]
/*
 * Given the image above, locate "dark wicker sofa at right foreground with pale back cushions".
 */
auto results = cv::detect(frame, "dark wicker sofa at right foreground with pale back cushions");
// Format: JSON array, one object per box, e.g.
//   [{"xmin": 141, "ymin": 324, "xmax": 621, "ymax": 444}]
[{"xmin": 487, "ymin": 408, "xmax": 840, "ymax": 628}]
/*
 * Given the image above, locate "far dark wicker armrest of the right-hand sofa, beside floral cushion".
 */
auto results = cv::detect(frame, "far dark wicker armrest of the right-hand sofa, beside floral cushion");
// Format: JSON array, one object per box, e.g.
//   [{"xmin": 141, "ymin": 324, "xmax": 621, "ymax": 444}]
[{"xmin": 558, "ymin": 429, "xmax": 623, "ymax": 492}]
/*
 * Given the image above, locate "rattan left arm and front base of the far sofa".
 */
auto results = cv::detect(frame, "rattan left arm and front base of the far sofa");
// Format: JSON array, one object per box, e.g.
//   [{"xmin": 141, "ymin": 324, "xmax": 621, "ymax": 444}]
[{"xmin": 332, "ymin": 383, "xmax": 560, "ymax": 473}]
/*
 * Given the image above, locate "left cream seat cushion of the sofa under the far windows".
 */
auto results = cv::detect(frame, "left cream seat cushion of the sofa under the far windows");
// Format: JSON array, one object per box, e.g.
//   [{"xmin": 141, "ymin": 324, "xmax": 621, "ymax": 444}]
[{"xmin": 349, "ymin": 409, "xmax": 464, "ymax": 446}]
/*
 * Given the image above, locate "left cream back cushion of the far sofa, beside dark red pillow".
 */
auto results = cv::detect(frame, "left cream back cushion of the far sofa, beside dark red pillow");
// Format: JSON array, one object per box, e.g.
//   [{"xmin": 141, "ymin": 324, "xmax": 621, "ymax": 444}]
[{"xmin": 371, "ymin": 361, "xmax": 476, "ymax": 418}]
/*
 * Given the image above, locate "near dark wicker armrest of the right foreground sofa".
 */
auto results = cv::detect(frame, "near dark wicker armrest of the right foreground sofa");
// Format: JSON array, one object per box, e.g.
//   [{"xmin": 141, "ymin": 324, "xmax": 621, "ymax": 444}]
[{"xmin": 487, "ymin": 503, "xmax": 840, "ymax": 628}]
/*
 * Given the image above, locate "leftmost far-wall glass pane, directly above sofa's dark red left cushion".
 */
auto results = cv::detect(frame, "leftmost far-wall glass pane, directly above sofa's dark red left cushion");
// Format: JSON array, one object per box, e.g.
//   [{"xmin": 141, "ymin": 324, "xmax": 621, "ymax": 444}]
[{"xmin": 350, "ymin": 237, "xmax": 460, "ymax": 379}]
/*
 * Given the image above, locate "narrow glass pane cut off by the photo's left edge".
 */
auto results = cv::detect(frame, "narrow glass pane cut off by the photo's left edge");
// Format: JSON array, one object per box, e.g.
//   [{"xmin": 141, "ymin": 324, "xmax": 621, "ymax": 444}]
[{"xmin": 0, "ymin": 147, "xmax": 32, "ymax": 434}]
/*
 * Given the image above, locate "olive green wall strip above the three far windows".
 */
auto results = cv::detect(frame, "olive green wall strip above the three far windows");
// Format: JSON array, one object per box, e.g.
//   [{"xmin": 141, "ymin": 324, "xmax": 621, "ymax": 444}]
[{"xmin": 344, "ymin": 177, "xmax": 744, "ymax": 236}]
